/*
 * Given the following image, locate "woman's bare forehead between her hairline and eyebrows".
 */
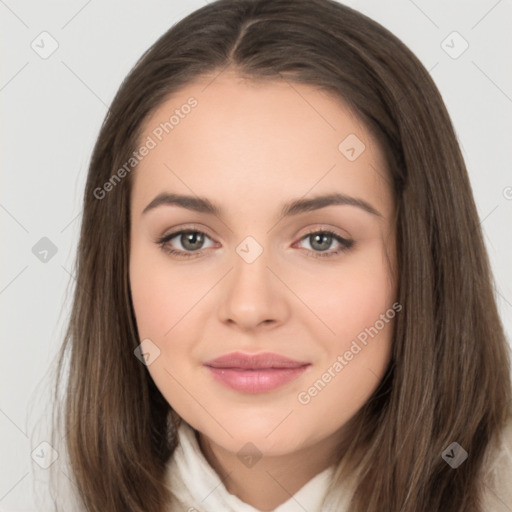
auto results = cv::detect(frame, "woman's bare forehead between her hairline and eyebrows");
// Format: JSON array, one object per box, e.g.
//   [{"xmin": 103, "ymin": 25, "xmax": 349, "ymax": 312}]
[{"xmin": 133, "ymin": 73, "xmax": 389, "ymax": 215}]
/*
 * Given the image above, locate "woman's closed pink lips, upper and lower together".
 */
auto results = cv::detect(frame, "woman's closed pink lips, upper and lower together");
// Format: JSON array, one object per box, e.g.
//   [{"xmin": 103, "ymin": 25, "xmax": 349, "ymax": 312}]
[{"xmin": 204, "ymin": 352, "xmax": 310, "ymax": 393}]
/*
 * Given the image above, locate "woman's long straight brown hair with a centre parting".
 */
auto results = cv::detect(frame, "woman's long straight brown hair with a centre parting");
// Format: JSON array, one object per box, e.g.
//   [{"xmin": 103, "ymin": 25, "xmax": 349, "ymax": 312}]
[{"xmin": 49, "ymin": 0, "xmax": 511, "ymax": 512}]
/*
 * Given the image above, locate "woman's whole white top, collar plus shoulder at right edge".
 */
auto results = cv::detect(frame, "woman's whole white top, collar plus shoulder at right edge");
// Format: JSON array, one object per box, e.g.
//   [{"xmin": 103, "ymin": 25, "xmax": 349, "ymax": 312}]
[{"xmin": 167, "ymin": 421, "xmax": 512, "ymax": 512}]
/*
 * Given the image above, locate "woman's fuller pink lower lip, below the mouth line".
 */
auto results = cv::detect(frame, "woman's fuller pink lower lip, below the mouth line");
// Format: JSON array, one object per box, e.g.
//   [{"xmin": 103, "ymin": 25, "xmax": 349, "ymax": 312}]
[{"xmin": 207, "ymin": 366, "xmax": 307, "ymax": 393}]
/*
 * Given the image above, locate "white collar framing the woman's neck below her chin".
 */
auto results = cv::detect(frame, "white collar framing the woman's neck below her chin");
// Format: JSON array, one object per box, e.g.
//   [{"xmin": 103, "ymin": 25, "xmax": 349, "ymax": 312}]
[{"xmin": 167, "ymin": 420, "xmax": 334, "ymax": 512}]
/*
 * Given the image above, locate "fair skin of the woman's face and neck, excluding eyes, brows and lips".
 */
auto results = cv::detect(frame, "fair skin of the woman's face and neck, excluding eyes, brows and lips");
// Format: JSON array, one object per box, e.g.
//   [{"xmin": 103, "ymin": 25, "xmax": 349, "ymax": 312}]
[{"xmin": 130, "ymin": 71, "xmax": 397, "ymax": 510}]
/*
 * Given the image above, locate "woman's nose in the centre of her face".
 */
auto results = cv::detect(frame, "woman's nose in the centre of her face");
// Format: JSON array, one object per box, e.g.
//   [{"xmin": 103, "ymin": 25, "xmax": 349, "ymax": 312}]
[{"xmin": 219, "ymin": 244, "xmax": 289, "ymax": 331}]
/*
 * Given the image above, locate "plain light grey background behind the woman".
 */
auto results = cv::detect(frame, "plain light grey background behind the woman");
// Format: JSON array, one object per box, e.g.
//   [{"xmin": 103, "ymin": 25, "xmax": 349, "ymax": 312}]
[{"xmin": 0, "ymin": 0, "xmax": 512, "ymax": 512}]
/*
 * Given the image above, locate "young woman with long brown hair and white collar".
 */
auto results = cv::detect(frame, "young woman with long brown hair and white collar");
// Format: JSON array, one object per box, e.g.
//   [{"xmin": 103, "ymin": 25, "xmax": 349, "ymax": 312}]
[{"xmin": 49, "ymin": 0, "xmax": 512, "ymax": 512}]
